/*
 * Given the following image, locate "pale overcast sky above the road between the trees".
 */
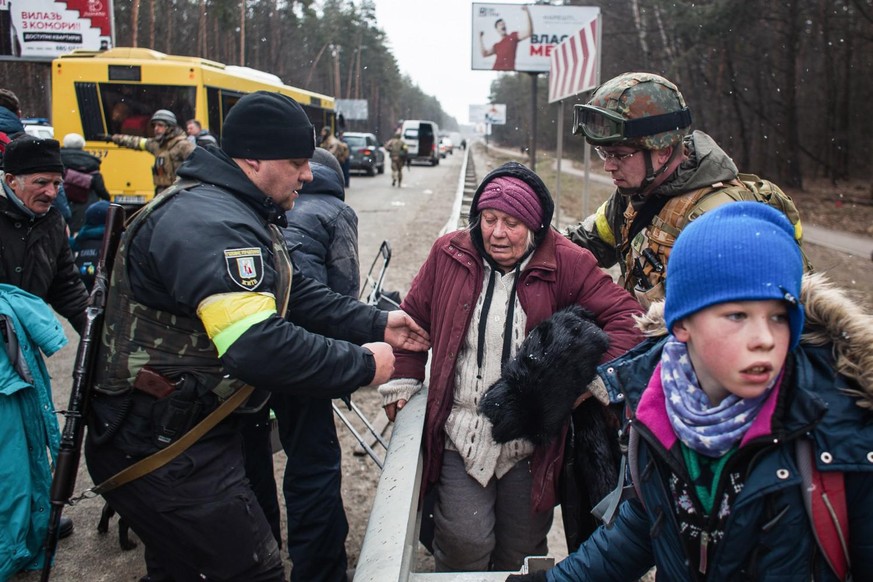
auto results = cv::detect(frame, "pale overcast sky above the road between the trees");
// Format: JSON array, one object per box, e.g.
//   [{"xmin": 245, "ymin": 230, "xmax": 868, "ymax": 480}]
[{"xmin": 365, "ymin": 0, "xmax": 529, "ymax": 123}]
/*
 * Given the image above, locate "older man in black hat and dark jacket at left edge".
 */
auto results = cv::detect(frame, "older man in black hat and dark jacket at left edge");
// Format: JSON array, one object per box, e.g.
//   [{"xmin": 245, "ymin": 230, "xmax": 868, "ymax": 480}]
[{"xmin": 0, "ymin": 135, "xmax": 88, "ymax": 334}]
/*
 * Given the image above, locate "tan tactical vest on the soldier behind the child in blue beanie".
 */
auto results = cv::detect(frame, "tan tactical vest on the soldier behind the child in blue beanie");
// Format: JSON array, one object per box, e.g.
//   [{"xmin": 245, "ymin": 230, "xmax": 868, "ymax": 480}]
[{"xmin": 622, "ymin": 174, "xmax": 812, "ymax": 308}]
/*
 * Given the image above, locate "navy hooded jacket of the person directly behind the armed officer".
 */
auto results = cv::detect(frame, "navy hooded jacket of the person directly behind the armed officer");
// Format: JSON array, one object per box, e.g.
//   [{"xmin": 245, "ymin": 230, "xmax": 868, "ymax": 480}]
[{"xmin": 283, "ymin": 162, "xmax": 360, "ymax": 297}]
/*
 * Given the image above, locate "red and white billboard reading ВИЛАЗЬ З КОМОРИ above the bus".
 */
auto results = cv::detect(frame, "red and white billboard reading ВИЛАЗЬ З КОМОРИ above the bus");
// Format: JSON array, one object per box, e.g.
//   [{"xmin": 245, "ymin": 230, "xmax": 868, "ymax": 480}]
[{"xmin": 0, "ymin": 0, "xmax": 113, "ymax": 60}]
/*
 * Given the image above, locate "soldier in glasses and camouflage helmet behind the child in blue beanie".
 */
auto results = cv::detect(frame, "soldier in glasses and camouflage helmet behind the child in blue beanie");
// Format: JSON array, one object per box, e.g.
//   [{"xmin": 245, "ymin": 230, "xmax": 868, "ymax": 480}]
[{"xmin": 566, "ymin": 73, "xmax": 800, "ymax": 307}]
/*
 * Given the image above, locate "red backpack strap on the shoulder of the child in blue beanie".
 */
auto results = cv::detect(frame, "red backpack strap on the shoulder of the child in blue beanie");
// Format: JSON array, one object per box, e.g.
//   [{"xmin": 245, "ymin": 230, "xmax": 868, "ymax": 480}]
[{"xmin": 795, "ymin": 438, "xmax": 851, "ymax": 580}]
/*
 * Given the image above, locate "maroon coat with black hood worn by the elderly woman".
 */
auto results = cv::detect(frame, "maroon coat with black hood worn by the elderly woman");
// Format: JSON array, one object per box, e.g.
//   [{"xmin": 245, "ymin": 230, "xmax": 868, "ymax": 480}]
[{"xmin": 393, "ymin": 164, "xmax": 640, "ymax": 511}]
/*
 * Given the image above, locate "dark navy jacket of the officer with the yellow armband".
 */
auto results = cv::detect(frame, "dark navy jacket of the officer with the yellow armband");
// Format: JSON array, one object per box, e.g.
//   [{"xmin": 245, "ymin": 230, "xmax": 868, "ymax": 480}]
[{"xmin": 92, "ymin": 148, "xmax": 387, "ymax": 451}]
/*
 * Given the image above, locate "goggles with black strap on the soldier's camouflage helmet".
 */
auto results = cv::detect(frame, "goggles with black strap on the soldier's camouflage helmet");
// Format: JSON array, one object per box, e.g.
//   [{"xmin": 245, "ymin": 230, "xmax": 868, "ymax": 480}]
[{"xmin": 573, "ymin": 105, "xmax": 691, "ymax": 144}]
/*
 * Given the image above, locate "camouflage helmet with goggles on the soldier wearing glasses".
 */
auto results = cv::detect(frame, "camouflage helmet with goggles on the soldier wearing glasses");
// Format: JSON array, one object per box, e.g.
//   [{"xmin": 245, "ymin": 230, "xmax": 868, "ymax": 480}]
[{"xmin": 573, "ymin": 73, "xmax": 691, "ymax": 150}]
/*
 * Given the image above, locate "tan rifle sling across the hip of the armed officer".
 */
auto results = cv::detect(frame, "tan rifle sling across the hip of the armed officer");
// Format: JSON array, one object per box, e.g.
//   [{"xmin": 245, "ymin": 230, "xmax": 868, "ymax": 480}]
[{"xmin": 87, "ymin": 384, "xmax": 254, "ymax": 495}]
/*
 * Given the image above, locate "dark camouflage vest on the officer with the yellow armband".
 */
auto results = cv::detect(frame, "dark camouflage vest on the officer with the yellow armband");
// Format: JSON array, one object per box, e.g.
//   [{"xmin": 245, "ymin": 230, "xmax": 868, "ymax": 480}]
[{"xmin": 94, "ymin": 181, "xmax": 292, "ymax": 400}]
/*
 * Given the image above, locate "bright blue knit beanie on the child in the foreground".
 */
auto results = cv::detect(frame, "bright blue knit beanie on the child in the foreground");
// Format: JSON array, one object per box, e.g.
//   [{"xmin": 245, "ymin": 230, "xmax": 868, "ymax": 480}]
[{"xmin": 664, "ymin": 202, "xmax": 804, "ymax": 349}]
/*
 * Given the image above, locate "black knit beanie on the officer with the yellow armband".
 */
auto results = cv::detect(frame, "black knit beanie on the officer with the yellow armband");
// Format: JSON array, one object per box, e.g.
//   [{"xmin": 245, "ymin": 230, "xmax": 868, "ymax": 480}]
[{"xmin": 221, "ymin": 91, "xmax": 315, "ymax": 160}]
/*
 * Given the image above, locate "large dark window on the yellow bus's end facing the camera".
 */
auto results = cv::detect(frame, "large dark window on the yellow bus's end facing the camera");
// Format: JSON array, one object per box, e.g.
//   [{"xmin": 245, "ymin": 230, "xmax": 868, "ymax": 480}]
[{"xmin": 99, "ymin": 83, "xmax": 196, "ymax": 137}]
